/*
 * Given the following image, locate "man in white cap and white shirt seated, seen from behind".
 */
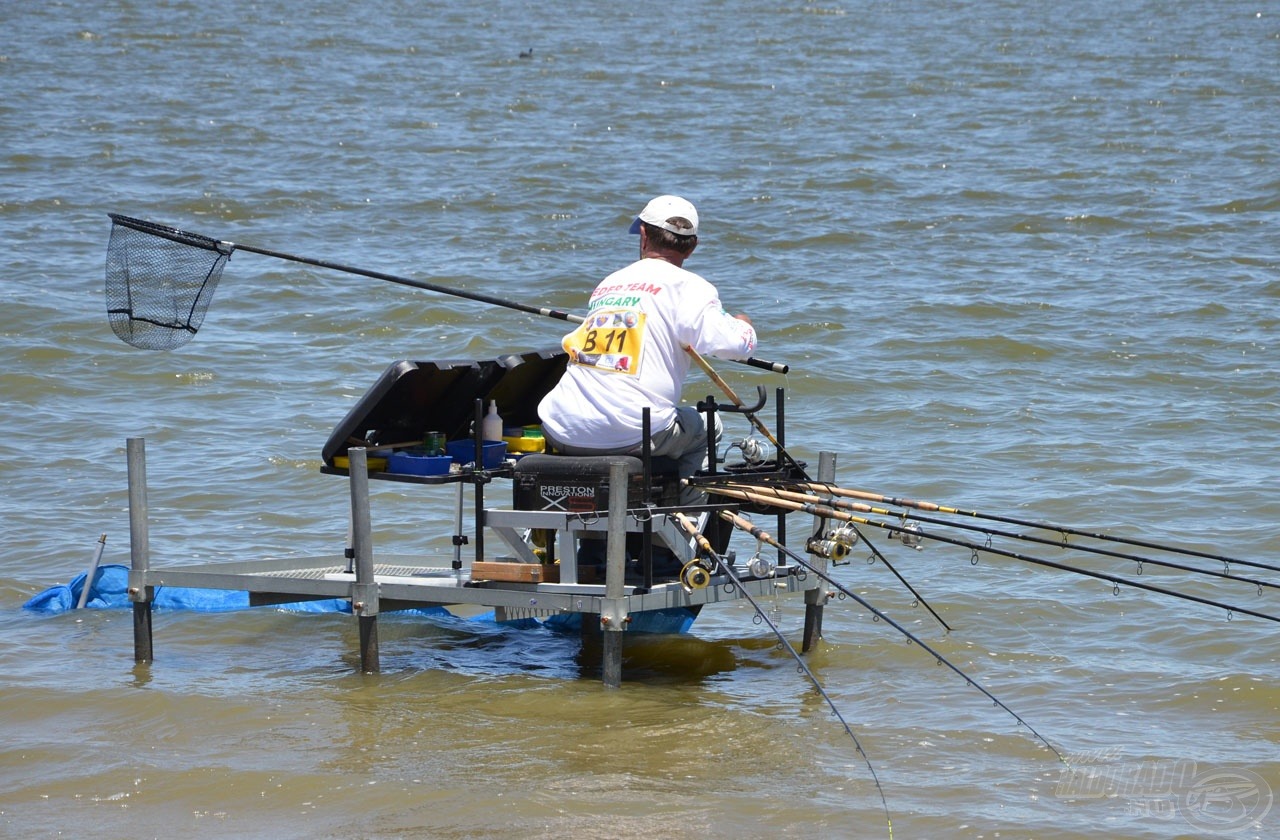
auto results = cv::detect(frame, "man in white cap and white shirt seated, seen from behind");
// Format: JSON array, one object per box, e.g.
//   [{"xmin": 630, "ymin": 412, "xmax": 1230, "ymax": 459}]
[{"xmin": 538, "ymin": 196, "xmax": 755, "ymax": 486}]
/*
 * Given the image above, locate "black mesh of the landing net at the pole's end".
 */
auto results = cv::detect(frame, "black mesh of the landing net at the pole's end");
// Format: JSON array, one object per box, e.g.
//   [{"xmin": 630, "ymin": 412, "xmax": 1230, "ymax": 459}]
[{"xmin": 106, "ymin": 214, "xmax": 233, "ymax": 350}]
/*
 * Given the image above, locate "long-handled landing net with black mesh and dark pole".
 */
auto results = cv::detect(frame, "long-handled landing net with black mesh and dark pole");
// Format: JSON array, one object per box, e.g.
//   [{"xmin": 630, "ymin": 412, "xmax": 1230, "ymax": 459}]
[{"xmin": 106, "ymin": 213, "xmax": 790, "ymax": 374}]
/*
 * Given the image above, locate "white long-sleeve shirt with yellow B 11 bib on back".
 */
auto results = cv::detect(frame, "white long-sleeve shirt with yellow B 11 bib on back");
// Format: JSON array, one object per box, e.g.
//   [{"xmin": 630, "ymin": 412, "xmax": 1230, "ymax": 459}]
[{"xmin": 538, "ymin": 259, "xmax": 755, "ymax": 449}]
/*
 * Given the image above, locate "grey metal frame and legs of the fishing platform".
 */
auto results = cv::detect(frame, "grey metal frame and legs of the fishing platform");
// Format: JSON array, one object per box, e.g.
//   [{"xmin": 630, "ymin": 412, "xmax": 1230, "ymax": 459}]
[{"xmin": 127, "ymin": 438, "xmax": 824, "ymax": 686}]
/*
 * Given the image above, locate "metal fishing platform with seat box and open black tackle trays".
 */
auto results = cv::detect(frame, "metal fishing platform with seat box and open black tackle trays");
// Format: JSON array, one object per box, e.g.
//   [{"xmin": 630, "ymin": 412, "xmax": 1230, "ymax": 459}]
[{"xmin": 128, "ymin": 351, "xmax": 835, "ymax": 685}]
